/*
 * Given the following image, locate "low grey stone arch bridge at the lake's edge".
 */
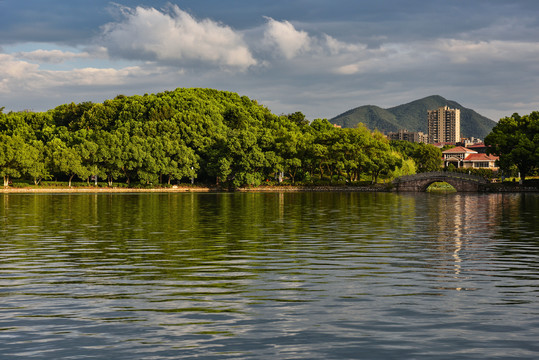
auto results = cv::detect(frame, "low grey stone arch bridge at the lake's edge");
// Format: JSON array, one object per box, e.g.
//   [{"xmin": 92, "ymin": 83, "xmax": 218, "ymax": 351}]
[{"xmin": 393, "ymin": 171, "xmax": 489, "ymax": 192}]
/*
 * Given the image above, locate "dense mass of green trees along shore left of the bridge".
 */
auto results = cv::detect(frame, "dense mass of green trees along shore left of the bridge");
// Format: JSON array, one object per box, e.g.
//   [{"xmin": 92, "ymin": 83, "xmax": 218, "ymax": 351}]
[{"xmin": 0, "ymin": 88, "xmax": 536, "ymax": 190}]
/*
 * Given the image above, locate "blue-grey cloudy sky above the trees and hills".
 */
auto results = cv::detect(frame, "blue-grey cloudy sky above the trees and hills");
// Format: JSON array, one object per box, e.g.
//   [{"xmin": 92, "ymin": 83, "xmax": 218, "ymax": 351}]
[{"xmin": 0, "ymin": 0, "xmax": 539, "ymax": 120}]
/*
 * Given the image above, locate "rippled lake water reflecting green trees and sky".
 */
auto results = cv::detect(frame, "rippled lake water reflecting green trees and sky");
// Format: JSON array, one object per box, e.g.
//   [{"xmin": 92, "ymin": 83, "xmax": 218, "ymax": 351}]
[{"xmin": 0, "ymin": 193, "xmax": 539, "ymax": 360}]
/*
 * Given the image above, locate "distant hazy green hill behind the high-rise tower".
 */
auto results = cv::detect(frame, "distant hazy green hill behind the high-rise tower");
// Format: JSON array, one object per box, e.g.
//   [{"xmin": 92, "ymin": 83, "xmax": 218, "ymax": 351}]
[{"xmin": 329, "ymin": 95, "xmax": 496, "ymax": 139}]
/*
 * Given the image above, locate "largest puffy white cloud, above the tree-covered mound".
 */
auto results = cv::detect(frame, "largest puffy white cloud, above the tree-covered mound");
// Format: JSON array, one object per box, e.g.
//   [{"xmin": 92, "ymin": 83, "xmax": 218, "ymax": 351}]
[{"xmin": 103, "ymin": 5, "xmax": 257, "ymax": 69}]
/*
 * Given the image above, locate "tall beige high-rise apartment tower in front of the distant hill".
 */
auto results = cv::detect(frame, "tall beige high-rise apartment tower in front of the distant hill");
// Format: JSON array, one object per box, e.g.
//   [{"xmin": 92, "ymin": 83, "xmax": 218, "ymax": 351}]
[{"xmin": 427, "ymin": 106, "xmax": 460, "ymax": 144}]
